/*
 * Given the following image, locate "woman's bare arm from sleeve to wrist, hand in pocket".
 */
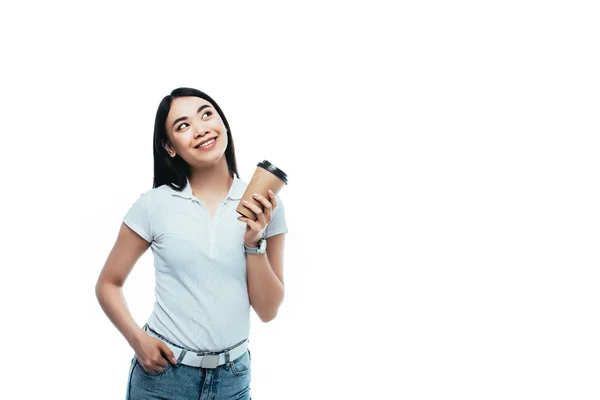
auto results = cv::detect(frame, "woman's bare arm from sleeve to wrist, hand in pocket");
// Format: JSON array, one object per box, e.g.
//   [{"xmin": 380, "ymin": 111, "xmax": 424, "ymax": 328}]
[{"xmin": 96, "ymin": 223, "xmax": 150, "ymax": 347}]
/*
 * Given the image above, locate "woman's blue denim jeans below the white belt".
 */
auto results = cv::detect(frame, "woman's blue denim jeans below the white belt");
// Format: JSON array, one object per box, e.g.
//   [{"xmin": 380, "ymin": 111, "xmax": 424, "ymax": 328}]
[{"xmin": 126, "ymin": 326, "xmax": 252, "ymax": 400}]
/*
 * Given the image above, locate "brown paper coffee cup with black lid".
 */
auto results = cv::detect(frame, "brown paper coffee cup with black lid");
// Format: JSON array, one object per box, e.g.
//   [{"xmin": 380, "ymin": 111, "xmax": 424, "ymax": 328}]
[{"xmin": 235, "ymin": 160, "xmax": 288, "ymax": 221}]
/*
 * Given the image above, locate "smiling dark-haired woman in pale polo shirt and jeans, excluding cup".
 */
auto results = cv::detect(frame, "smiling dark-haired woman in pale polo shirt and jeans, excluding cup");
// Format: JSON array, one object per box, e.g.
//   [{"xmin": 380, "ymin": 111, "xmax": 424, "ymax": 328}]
[{"xmin": 96, "ymin": 88, "xmax": 287, "ymax": 400}]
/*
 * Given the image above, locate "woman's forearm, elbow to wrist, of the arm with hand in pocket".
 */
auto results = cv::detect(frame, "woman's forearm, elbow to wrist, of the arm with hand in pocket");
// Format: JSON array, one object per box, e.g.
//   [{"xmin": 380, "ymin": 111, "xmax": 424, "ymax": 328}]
[{"xmin": 96, "ymin": 283, "xmax": 145, "ymax": 347}]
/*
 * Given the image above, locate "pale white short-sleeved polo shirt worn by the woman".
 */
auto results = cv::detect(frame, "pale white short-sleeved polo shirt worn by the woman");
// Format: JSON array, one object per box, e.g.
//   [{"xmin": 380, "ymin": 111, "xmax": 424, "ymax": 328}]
[{"xmin": 123, "ymin": 175, "xmax": 287, "ymax": 351}]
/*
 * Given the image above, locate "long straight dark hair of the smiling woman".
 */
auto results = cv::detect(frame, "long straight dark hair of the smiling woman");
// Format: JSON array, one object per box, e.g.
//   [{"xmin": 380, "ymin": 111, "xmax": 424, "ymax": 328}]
[{"xmin": 152, "ymin": 87, "xmax": 239, "ymax": 191}]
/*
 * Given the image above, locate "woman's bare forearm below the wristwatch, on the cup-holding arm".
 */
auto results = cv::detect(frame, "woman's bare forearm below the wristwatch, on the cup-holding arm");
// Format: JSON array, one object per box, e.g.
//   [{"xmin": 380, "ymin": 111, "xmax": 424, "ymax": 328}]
[{"xmin": 246, "ymin": 254, "xmax": 284, "ymax": 322}]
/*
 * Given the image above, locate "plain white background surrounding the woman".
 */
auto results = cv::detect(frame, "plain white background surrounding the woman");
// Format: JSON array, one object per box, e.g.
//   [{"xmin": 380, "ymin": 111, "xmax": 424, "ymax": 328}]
[{"xmin": 0, "ymin": 1, "xmax": 600, "ymax": 400}]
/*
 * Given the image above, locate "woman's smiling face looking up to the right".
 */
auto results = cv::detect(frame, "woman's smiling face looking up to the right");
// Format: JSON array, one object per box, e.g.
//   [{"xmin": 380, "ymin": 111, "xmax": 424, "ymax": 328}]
[{"xmin": 164, "ymin": 96, "xmax": 227, "ymax": 167}]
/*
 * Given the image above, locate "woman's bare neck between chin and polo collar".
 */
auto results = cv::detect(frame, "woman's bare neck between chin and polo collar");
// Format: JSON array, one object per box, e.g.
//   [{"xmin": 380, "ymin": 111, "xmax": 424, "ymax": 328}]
[{"xmin": 189, "ymin": 156, "xmax": 233, "ymax": 197}]
